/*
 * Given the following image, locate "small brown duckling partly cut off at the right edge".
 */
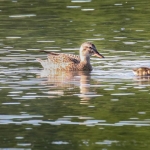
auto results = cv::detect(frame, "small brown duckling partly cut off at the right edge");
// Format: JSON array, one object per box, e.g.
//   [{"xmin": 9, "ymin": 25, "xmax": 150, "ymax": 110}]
[{"xmin": 133, "ymin": 67, "xmax": 150, "ymax": 76}]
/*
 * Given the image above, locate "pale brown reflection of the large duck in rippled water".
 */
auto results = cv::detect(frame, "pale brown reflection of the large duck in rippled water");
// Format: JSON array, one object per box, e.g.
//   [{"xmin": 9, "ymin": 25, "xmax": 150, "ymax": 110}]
[{"xmin": 37, "ymin": 69, "xmax": 95, "ymax": 104}]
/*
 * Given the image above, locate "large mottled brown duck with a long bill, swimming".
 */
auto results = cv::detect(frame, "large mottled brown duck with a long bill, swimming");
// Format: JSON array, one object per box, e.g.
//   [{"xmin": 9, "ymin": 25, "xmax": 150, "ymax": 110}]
[{"xmin": 37, "ymin": 42, "xmax": 104, "ymax": 71}]
